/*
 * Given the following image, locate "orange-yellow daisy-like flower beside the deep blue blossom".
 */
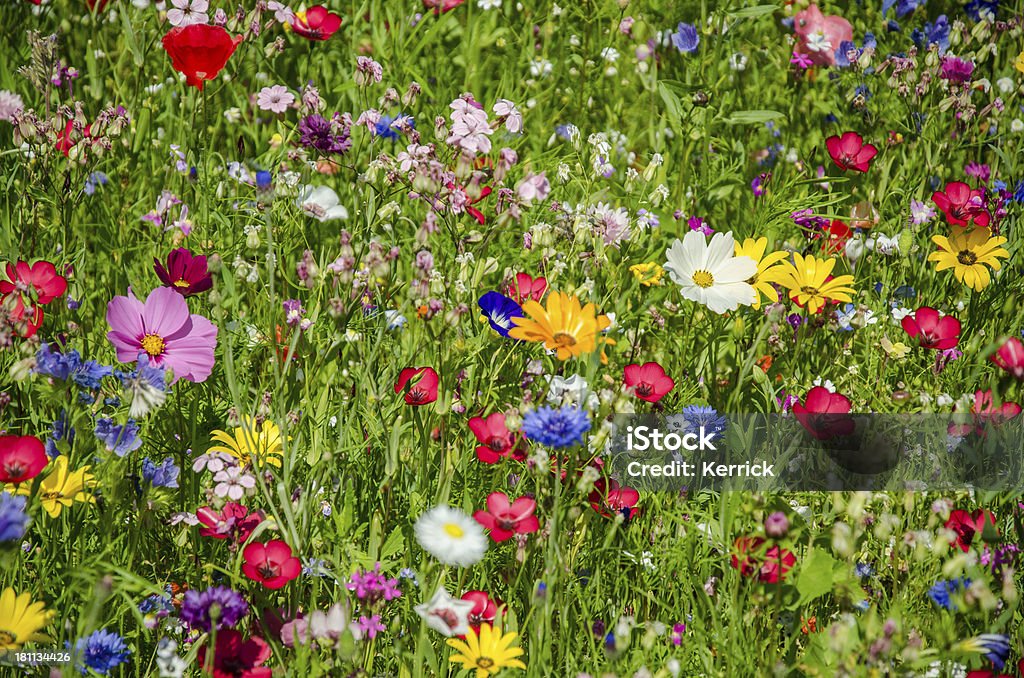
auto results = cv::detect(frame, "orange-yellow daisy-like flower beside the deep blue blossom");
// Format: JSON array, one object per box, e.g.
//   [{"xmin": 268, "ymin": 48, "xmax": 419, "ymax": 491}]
[{"xmin": 509, "ymin": 292, "xmax": 611, "ymax": 361}]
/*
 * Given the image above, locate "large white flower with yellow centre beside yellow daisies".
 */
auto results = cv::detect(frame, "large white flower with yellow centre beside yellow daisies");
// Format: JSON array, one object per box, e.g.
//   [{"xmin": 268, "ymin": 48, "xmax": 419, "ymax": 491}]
[{"xmin": 665, "ymin": 230, "xmax": 758, "ymax": 313}]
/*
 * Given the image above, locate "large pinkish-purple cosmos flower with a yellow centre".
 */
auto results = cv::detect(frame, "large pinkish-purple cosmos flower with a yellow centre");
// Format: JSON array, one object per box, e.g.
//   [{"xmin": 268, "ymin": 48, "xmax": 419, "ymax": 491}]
[{"xmin": 106, "ymin": 287, "xmax": 217, "ymax": 382}]
